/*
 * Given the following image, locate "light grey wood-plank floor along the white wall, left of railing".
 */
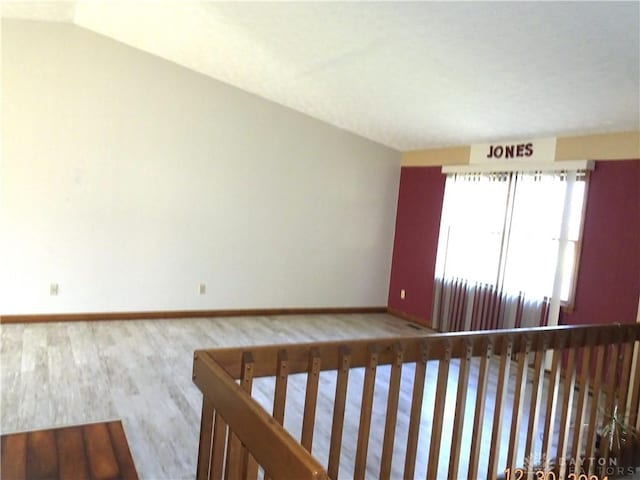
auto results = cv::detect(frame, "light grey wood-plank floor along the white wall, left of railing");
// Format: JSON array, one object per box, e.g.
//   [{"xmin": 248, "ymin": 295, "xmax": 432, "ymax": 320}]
[{"xmin": 0, "ymin": 314, "xmax": 430, "ymax": 479}]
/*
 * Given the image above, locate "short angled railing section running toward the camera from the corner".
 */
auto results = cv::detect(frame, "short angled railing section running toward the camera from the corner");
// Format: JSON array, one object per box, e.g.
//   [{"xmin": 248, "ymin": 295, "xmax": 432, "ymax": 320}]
[{"xmin": 193, "ymin": 352, "xmax": 326, "ymax": 480}]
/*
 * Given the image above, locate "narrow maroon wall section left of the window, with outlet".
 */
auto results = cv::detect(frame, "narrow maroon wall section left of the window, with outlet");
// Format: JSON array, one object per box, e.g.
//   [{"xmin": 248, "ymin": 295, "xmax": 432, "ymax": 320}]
[{"xmin": 389, "ymin": 167, "xmax": 445, "ymax": 325}]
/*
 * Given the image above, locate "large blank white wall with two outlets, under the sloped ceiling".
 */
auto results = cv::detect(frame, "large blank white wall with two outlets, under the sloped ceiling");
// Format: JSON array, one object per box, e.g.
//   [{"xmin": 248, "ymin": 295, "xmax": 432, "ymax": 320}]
[{"xmin": 0, "ymin": 20, "xmax": 400, "ymax": 314}]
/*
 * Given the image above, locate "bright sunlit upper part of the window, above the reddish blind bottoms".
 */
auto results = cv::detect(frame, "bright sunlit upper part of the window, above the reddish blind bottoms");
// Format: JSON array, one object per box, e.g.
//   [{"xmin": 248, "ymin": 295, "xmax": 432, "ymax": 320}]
[{"xmin": 436, "ymin": 171, "xmax": 586, "ymax": 330}]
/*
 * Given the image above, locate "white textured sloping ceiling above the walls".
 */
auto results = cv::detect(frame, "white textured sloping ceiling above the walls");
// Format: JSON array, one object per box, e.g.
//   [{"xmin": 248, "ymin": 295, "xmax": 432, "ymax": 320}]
[{"xmin": 2, "ymin": 0, "xmax": 640, "ymax": 151}]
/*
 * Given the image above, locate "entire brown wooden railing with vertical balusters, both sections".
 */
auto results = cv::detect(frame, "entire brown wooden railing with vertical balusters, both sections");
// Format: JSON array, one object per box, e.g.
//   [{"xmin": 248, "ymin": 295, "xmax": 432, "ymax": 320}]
[{"xmin": 193, "ymin": 324, "xmax": 640, "ymax": 480}]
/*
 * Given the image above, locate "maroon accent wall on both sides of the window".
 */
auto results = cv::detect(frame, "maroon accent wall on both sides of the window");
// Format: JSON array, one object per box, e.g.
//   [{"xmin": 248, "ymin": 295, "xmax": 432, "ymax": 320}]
[{"xmin": 388, "ymin": 160, "xmax": 640, "ymax": 325}]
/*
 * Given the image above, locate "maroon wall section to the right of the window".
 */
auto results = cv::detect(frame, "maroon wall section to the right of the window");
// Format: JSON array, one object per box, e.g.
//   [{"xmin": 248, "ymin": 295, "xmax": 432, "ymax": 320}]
[{"xmin": 561, "ymin": 160, "xmax": 640, "ymax": 325}]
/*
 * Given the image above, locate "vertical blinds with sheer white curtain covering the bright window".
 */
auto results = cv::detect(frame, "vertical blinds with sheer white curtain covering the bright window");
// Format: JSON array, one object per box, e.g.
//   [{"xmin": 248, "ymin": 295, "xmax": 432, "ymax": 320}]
[{"xmin": 433, "ymin": 171, "xmax": 585, "ymax": 331}]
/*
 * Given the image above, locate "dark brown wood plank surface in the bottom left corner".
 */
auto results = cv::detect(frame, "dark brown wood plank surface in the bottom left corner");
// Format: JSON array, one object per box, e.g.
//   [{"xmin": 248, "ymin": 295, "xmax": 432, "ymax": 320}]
[{"xmin": 0, "ymin": 420, "xmax": 138, "ymax": 480}]
